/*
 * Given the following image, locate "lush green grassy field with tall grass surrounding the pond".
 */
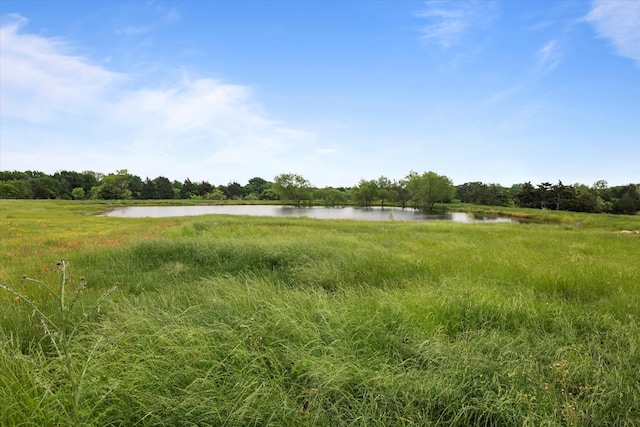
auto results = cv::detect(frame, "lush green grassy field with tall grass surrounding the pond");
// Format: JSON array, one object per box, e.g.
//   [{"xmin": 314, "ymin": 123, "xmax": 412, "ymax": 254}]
[{"xmin": 0, "ymin": 201, "xmax": 640, "ymax": 426}]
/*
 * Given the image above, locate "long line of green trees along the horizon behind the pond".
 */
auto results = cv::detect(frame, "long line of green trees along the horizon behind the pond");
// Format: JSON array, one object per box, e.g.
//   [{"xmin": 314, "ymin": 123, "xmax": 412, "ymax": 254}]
[{"xmin": 0, "ymin": 169, "xmax": 640, "ymax": 214}]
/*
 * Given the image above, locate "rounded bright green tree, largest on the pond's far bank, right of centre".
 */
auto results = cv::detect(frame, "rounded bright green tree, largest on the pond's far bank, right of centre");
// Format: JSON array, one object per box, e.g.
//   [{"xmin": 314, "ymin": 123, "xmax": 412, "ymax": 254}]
[{"xmin": 407, "ymin": 172, "xmax": 455, "ymax": 212}]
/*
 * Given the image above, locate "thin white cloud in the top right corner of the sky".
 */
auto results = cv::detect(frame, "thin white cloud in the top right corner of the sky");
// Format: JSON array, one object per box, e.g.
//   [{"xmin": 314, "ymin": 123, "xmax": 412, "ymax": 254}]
[{"xmin": 585, "ymin": 0, "xmax": 640, "ymax": 67}]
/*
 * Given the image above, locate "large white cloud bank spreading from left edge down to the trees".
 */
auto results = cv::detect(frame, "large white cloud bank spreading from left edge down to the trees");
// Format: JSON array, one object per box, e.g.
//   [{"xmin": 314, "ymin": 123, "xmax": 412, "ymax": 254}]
[{"xmin": 0, "ymin": 16, "xmax": 315, "ymax": 179}]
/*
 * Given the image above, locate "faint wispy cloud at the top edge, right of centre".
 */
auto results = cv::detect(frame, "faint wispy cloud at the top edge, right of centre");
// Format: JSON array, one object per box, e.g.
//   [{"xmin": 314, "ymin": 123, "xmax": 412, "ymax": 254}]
[{"xmin": 417, "ymin": 0, "xmax": 496, "ymax": 49}]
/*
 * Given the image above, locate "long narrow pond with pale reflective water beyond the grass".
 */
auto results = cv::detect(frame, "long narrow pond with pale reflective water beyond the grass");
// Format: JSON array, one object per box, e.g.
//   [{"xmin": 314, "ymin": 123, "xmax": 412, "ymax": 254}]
[{"xmin": 105, "ymin": 205, "xmax": 518, "ymax": 223}]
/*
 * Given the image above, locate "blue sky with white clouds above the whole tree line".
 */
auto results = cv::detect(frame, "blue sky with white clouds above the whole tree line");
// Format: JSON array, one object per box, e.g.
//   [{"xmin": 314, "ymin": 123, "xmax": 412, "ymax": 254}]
[{"xmin": 0, "ymin": 0, "xmax": 640, "ymax": 187}]
